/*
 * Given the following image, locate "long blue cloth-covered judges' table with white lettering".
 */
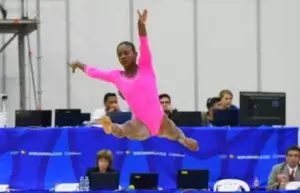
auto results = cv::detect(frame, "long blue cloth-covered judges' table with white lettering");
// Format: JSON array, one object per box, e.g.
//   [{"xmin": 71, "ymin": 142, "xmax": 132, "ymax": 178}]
[{"xmin": 0, "ymin": 127, "xmax": 298, "ymax": 190}]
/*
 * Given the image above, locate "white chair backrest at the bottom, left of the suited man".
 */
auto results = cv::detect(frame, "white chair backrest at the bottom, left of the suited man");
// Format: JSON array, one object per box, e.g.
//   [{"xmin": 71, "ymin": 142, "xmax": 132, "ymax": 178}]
[{"xmin": 214, "ymin": 179, "xmax": 250, "ymax": 192}]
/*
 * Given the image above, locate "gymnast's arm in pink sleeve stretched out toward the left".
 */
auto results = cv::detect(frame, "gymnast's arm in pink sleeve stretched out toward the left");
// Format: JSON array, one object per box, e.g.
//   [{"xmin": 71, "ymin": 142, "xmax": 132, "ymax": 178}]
[{"xmin": 71, "ymin": 62, "xmax": 117, "ymax": 82}]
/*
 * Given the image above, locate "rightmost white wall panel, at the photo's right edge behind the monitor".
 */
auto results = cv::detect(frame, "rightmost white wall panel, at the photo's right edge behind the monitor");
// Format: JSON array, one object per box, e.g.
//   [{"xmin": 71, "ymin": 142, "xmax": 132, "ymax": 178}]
[{"xmin": 261, "ymin": 0, "xmax": 300, "ymax": 125}]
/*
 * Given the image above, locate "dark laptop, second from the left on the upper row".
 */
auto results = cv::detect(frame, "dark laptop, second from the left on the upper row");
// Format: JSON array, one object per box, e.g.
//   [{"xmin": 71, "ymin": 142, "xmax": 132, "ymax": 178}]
[{"xmin": 55, "ymin": 109, "xmax": 82, "ymax": 127}]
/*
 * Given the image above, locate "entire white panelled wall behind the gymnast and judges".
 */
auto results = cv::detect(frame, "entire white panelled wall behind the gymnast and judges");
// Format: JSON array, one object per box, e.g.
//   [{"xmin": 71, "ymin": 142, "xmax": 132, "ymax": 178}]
[{"xmin": 0, "ymin": 0, "xmax": 300, "ymax": 125}]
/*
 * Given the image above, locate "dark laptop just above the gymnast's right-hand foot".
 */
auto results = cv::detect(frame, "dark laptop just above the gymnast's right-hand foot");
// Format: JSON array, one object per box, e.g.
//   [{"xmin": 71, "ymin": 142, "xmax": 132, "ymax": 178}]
[{"xmin": 173, "ymin": 111, "xmax": 202, "ymax": 127}]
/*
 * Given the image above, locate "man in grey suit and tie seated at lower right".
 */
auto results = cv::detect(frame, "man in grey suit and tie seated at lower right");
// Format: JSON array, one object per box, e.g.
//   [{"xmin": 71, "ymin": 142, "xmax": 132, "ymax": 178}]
[{"xmin": 267, "ymin": 145, "xmax": 300, "ymax": 190}]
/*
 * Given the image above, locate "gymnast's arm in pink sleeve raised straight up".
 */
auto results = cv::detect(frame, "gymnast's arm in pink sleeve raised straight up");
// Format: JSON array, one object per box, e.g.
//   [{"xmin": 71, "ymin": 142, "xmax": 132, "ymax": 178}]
[{"xmin": 138, "ymin": 11, "xmax": 153, "ymax": 69}]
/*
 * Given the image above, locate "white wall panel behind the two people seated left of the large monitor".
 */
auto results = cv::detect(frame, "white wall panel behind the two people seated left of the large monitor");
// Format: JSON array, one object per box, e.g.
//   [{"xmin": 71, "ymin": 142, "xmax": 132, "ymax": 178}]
[{"xmin": 198, "ymin": 0, "xmax": 257, "ymax": 111}]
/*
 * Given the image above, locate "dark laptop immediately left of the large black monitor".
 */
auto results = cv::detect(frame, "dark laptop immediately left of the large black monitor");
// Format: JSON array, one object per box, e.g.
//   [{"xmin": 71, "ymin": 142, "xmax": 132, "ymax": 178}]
[{"xmin": 213, "ymin": 109, "xmax": 239, "ymax": 127}]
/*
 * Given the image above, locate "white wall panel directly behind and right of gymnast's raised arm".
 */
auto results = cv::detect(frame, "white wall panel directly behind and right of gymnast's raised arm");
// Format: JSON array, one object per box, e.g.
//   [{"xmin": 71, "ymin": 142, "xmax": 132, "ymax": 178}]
[{"xmin": 134, "ymin": 0, "xmax": 195, "ymax": 110}]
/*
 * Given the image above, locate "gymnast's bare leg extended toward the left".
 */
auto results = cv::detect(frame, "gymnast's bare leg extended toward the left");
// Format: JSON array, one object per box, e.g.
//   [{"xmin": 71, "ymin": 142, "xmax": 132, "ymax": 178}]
[{"xmin": 99, "ymin": 116, "xmax": 151, "ymax": 140}]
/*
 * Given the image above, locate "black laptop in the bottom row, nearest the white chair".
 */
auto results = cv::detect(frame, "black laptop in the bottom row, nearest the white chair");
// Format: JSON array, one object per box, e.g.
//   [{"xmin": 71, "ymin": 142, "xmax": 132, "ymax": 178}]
[{"xmin": 177, "ymin": 170, "xmax": 209, "ymax": 190}]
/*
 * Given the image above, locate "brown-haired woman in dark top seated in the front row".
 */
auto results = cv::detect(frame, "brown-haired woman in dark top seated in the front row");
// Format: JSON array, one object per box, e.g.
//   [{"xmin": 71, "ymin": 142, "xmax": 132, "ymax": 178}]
[{"xmin": 86, "ymin": 150, "xmax": 116, "ymax": 180}]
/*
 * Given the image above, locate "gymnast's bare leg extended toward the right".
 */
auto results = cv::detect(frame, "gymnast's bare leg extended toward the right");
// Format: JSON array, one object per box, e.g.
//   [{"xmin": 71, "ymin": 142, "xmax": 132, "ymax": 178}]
[{"xmin": 158, "ymin": 115, "xmax": 199, "ymax": 151}]
